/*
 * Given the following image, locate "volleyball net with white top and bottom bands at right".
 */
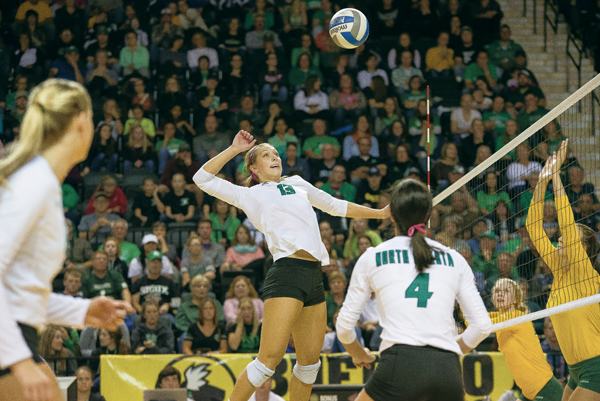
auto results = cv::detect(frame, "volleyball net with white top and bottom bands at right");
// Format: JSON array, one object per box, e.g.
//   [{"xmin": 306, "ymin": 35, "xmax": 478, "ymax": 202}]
[{"xmin": 430, "ymin": 75, "xmax": 600, "ymax": 333}]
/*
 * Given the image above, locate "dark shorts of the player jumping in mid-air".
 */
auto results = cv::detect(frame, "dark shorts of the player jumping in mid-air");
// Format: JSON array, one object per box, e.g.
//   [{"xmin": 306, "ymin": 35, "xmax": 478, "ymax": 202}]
[{"xmin": 263, "ymin": 258, "xmax": 325, "ymax": 306}]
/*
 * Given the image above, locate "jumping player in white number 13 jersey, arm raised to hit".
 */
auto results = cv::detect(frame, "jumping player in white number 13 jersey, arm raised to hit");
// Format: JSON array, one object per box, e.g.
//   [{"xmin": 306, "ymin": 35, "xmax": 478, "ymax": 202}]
[{"xmin": 194, "ymin": 131, "xmax": 389, "ymax": 401}]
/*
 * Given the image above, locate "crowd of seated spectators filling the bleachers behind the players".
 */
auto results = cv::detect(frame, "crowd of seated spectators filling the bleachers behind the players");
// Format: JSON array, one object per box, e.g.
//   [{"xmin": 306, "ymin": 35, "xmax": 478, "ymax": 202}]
[{"xmin": 0, "ymin": 0, "xmax": 600, "ymax": 390}]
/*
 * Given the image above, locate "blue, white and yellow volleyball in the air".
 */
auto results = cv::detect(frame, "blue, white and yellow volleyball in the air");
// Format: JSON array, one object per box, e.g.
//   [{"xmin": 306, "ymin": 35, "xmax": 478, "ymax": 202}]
[{"xmin": 329, "ymin": 8, "xmax": 369, "ymax": 49}]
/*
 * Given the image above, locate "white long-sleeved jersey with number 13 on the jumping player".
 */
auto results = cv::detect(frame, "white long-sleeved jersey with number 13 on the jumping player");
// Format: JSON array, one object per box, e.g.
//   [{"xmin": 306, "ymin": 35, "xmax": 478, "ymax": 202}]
[{"xmin": 194, "ymin": 168, "xmax": 348, "ymax": 265}]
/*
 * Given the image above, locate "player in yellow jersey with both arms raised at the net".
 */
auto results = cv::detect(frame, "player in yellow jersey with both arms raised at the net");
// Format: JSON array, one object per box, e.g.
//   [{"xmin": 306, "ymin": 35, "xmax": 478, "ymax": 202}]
[{"xmin": 527, "ymin": 140, "xmax": 600, "ymax": 401}]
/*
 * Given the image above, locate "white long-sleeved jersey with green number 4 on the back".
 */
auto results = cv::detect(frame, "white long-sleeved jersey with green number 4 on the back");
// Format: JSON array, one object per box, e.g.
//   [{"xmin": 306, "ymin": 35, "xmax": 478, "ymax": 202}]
[{"xmin": 336, "ymin": 236, "xmax": 492, "ymax": 355}]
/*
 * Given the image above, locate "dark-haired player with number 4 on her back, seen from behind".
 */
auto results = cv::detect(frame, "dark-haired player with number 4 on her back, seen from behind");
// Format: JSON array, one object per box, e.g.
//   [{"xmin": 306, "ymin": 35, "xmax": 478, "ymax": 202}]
[{"xmin": 336, "ymin": 179, "xmax": 492, "ymax": 401}]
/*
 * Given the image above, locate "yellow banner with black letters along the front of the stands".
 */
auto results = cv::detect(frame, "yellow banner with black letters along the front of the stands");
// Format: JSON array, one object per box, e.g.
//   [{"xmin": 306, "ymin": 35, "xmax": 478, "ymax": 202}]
[{"xmin": 100, "ymin": 352, "xmax": 514, "ymax": 401}]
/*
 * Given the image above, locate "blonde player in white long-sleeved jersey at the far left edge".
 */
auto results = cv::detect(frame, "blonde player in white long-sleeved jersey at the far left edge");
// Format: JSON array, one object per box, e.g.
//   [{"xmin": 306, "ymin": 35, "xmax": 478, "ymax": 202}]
[{"xmin": 0, "ymin": 79, "xmax": 133, "ymax": 401}]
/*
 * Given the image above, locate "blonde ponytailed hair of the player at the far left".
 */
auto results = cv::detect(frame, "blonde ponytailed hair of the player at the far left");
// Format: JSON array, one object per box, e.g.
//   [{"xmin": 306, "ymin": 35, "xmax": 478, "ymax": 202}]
[{"xmin": 0, "ymin": 79, "xmax": 92, "ymax": 185}]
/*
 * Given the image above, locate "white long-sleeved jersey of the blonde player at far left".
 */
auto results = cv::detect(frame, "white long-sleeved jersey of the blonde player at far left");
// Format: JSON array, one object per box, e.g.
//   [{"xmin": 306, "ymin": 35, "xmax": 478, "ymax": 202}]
[{"xmin": 0, "ymin": 156, "xmax": 90, "ymax": 369}]
